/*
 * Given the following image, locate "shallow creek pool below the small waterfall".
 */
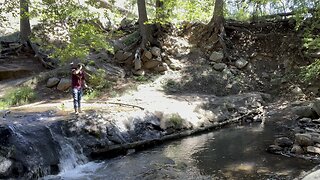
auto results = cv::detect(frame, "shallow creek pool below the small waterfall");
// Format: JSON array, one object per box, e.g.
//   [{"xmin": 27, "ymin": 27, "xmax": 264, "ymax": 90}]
[{"xmin": 45, "ymin": 122, "xmax": 315, "ymax": 180}]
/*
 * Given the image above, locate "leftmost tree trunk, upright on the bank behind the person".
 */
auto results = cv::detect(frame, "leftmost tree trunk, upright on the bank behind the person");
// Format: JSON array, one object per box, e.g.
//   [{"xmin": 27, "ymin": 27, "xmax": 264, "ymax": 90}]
[{"xmin": 20, "ymin": 0, "xmax": 31, "ymax": 43}]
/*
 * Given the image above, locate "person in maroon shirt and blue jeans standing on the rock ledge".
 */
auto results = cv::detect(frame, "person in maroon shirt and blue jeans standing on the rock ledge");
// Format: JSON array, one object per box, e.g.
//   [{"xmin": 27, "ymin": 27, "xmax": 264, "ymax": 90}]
[{"xmin": 71, "ymin": 63, "xmax": 86, "ymax": 114}]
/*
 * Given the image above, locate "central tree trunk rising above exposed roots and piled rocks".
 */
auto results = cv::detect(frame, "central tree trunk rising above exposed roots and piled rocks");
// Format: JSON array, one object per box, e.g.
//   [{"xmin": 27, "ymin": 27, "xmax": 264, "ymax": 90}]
[{"xmin": 137, "ymin": 0, "xmax": 152, "ymax": 49}]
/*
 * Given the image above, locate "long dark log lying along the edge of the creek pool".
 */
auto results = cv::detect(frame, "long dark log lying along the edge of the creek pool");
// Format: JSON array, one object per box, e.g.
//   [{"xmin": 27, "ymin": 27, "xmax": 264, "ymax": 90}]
[{"xmin": 91, "ymin": 109, "xmax": 259, "ymax": 159}]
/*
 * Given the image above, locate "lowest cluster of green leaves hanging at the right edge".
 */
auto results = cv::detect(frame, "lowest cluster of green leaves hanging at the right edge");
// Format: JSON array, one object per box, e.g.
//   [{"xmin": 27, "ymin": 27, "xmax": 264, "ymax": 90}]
[{"xmin": 300, "ymin": 59, "xmax": 320, "ymax": 81}]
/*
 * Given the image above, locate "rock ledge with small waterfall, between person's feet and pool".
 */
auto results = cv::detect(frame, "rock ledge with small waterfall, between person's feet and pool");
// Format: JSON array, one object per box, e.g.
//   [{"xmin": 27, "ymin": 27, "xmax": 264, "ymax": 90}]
[{"xmin": 0, "ymin": 93, "xmax": 270, "ymax": 179}]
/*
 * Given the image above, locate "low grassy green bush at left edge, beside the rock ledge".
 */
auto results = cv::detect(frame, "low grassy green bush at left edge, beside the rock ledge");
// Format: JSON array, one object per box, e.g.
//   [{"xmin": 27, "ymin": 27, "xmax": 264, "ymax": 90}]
[{"xmin": 0, "ymin": 87, "xmax": 36, "ymax": 107}]
